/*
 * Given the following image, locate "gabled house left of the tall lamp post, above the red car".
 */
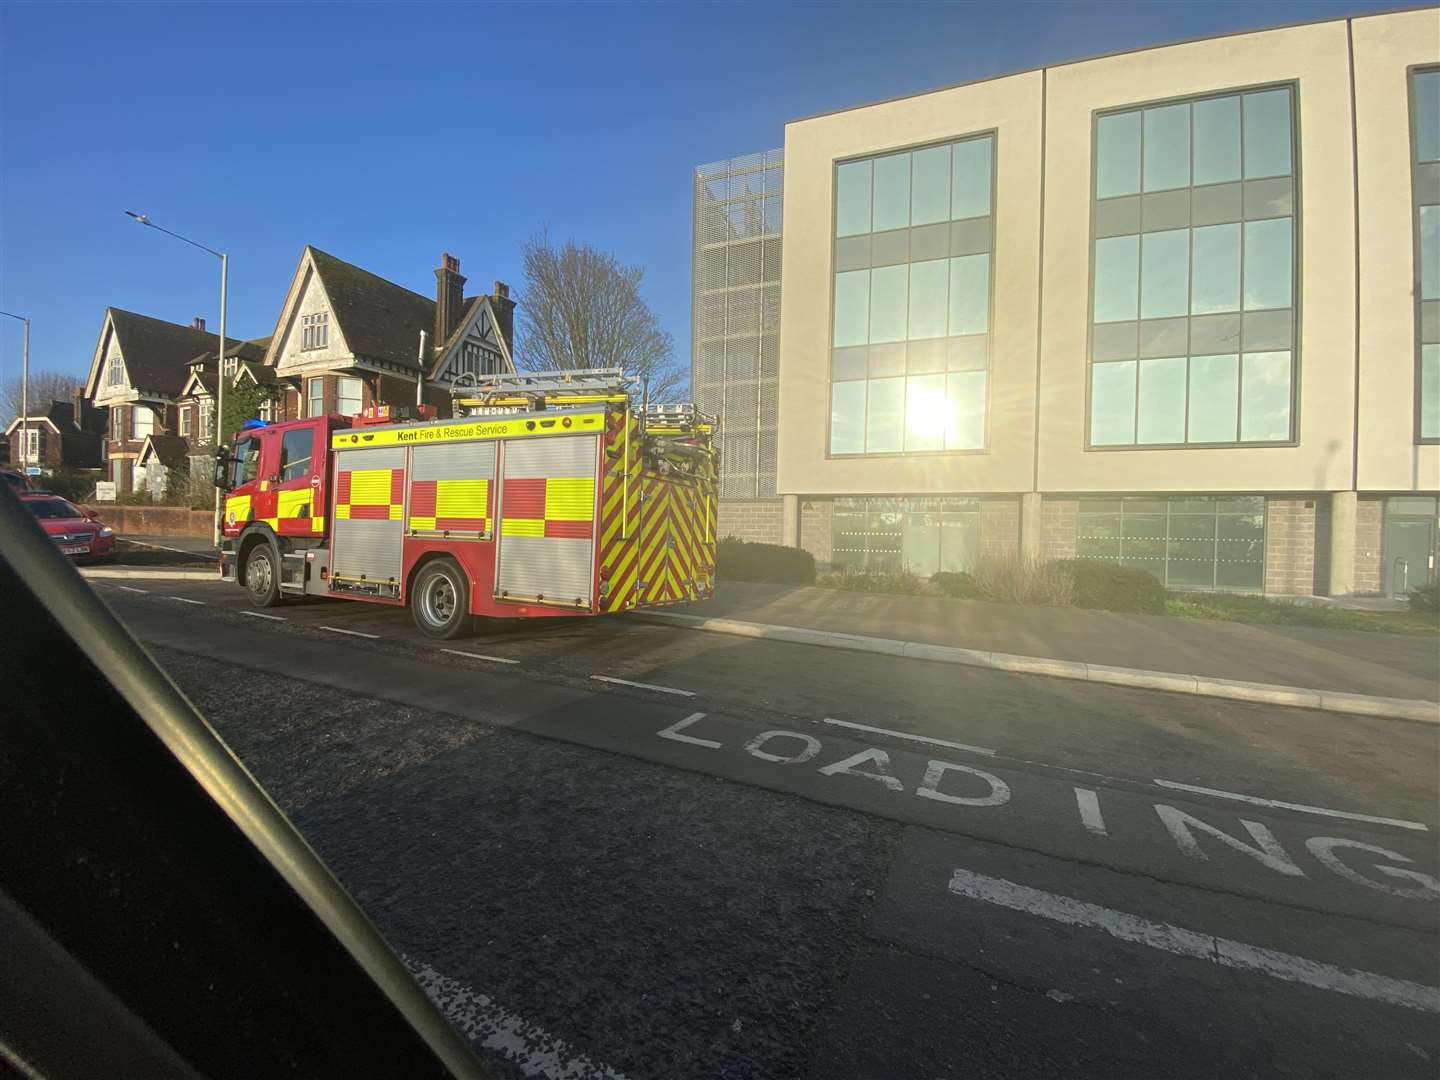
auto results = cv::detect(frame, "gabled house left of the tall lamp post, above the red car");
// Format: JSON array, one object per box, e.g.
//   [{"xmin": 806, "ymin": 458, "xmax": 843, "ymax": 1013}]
[{"xmin": 85, "ymin": 308, "xmax": 264, "ymax": 494}]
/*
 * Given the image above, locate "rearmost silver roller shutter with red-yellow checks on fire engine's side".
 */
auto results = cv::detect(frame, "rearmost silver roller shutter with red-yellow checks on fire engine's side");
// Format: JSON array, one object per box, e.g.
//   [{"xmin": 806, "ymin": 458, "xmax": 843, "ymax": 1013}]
[{"xmin": 495, "ymin": 435, "xmax": 598, "ymax": 608}]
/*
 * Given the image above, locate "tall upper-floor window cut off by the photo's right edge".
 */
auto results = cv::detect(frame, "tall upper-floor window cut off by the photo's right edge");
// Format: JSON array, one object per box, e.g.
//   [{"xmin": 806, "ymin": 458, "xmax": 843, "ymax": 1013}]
[{"xmin": 1410, "ymin": 68, "xmax": 1440, "ymax": 442}]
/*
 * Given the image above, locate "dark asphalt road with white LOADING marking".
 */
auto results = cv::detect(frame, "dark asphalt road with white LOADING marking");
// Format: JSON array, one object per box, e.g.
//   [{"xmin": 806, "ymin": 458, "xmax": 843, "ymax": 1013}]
[{"xmin": 94, "ymin": 580, "xmax": 1440, "ymax": 1080}]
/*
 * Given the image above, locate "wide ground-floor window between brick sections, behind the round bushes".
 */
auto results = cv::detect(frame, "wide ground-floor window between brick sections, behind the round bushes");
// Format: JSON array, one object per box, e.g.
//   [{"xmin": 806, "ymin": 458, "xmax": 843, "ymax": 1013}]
[{"xmin": 1076, "ymin": 495, "xmax": 1264, "ymax": 592}]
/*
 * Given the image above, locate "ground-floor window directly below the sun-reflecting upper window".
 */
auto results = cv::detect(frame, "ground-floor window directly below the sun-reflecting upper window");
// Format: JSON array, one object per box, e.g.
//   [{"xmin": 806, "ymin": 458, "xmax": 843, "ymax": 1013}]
[{"xmin": 831, "ymin": 497, "xmax": 981, "ymax": 577}]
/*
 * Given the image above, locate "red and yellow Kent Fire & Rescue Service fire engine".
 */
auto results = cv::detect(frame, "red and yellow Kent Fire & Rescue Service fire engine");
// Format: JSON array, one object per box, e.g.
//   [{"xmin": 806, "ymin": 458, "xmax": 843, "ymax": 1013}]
[{"xmin": 215, "ymin": 369, "xmax": 717, "ymax": 638}]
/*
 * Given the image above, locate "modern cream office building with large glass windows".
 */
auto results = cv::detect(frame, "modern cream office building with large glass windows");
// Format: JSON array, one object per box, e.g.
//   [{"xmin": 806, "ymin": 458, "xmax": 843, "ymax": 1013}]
[{"xmin": 696, "ymin": 7, "xmax": 1440, "ymax": 595}]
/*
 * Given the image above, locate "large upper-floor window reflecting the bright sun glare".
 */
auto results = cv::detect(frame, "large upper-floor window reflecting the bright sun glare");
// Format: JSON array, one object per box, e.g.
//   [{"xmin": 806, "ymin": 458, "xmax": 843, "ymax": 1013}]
[{"xmin": 829, "ymin": 135, "xmax": 995, "ymax": 455}]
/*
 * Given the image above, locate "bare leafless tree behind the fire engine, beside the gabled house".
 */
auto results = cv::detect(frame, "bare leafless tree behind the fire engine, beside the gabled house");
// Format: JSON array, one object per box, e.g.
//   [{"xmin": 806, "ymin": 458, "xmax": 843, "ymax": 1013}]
[{"xmin": 516, "ymin": 232, "xmax": 685, "ymax": 402}]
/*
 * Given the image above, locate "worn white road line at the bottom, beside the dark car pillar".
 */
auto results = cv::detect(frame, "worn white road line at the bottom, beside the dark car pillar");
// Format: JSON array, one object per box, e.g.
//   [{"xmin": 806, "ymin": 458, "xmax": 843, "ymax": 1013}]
[{"xmin": 405, "ymin": 958, "xmax": 625, "ymax": 1080}]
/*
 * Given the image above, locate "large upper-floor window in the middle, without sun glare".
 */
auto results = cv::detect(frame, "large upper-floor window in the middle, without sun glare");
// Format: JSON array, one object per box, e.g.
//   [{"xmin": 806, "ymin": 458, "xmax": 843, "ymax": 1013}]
[{"xmin": 1089, "ymin": 88, "xmax": 1297, "ymax": 446}]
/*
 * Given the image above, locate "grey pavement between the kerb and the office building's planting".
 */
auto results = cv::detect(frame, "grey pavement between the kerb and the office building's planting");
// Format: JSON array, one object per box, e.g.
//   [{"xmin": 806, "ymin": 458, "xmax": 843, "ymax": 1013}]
[{"xmin": 674, "ymin": 582, "xmax": 1440, "ymax": 701}]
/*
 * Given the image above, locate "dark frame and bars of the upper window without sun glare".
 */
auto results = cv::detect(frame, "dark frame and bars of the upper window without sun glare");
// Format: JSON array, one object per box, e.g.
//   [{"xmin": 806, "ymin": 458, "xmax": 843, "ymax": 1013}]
[{"xmin": 1081, "ymin": 79, "xmax": 1307, "ymax": 454}]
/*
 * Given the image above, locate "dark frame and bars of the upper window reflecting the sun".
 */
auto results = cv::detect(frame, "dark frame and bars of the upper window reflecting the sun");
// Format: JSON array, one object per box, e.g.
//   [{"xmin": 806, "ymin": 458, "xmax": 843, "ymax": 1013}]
[{"xmin": 822, "ymin": 125, "xmax": 999, "ymax": 461}]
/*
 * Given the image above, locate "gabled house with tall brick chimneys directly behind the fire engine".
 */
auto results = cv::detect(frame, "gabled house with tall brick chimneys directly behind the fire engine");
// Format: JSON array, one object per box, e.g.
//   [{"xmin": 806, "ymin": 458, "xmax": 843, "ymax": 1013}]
[{"xmin": 262, "ymin": 245, "xmax": 516, "ymax": 419}]
